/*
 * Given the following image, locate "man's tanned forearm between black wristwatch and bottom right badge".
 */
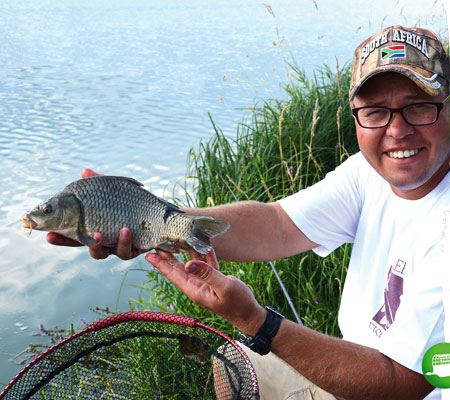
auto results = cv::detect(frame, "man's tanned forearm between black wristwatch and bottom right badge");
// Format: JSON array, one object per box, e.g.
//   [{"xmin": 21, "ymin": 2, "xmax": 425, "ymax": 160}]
[{"xmin": 271, "ymin": 320, "xmax": 432, "ymax": 399}]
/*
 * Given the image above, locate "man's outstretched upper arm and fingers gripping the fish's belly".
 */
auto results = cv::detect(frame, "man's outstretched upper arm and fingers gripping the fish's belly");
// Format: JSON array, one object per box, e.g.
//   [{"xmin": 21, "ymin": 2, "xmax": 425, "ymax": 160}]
[{"xmin": 47, "ymin": 168, "xmax": 318, "ymax": 262}]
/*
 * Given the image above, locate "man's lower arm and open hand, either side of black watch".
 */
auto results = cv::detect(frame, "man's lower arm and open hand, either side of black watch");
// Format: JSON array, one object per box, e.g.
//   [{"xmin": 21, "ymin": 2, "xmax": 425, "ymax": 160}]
[{"xmin": 146, "ymin": 251, "xmax": 433, "ymax": 400}]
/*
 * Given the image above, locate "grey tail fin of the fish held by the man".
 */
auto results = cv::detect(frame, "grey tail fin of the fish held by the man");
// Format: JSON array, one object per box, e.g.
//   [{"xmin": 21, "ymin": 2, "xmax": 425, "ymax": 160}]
[{"xmin": 186, "ymin": 217, "xmax": 230, "ymax": 254}]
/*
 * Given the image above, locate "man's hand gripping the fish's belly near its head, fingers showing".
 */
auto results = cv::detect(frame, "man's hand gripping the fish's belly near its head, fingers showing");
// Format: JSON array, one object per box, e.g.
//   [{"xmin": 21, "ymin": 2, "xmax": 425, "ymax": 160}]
[{"xmin": 47, "ymin": 168, "xmax": 144, "ymax": 260}]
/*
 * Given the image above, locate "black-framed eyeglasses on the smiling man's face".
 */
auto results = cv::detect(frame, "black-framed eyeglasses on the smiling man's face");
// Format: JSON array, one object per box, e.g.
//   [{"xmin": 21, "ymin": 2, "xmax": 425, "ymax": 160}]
[{"xmin": 352, "ymin": 95, "xmax": 450, "ymax": 129}]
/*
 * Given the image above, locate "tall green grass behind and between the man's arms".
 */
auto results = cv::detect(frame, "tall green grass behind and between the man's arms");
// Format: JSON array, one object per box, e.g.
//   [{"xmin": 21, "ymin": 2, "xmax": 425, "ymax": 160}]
[{"xmin": 135, "ymin": 61, "xmax": 358, "ymax": 336}]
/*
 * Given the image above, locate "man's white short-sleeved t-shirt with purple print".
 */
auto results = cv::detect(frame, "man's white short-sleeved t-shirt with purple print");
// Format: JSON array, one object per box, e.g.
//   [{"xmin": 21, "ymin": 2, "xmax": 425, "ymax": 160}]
[{"xmin": 279, "ymin": 153, "xmax": 450, "ymax": 398}]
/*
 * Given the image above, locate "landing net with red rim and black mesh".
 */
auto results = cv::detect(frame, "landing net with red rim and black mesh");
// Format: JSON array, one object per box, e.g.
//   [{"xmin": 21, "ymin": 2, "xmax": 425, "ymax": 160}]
[{"xmin": 0, "ymin": 312, "xmax": 258, "ymax": 400}]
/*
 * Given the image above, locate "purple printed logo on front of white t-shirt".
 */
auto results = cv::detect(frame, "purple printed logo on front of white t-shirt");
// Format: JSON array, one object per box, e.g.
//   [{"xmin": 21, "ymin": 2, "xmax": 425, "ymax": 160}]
[{"xmin": 369, "ymin": 259, "xmax": 406, "ymax": 337}]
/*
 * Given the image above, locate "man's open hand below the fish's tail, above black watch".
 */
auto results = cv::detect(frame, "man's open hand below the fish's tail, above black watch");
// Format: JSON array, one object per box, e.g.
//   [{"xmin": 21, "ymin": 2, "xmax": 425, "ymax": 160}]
[{"xmin": 145, "ymin": 250, "xmax": 267, "ymax": 335}]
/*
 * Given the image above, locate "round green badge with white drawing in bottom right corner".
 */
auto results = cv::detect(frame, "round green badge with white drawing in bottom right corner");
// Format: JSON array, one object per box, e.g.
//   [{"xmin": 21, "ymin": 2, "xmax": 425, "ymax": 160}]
[{"xmin": 422, "ymin": 343, "xmax": 450, "ymax": 389}]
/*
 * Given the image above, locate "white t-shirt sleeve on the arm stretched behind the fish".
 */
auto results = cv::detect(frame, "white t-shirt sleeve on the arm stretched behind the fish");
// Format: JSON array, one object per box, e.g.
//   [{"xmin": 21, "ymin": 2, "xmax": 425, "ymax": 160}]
[{"xmin": 278, "ymin": 153, "xmax": 370, "ymax": 257}]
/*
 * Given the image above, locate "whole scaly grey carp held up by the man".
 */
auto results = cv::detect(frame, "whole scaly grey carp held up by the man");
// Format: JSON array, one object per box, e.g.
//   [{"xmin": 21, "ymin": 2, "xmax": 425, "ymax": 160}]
[{"xmin": 22, "ymin": 176, "xmax": 229, "ymax": 254}]
